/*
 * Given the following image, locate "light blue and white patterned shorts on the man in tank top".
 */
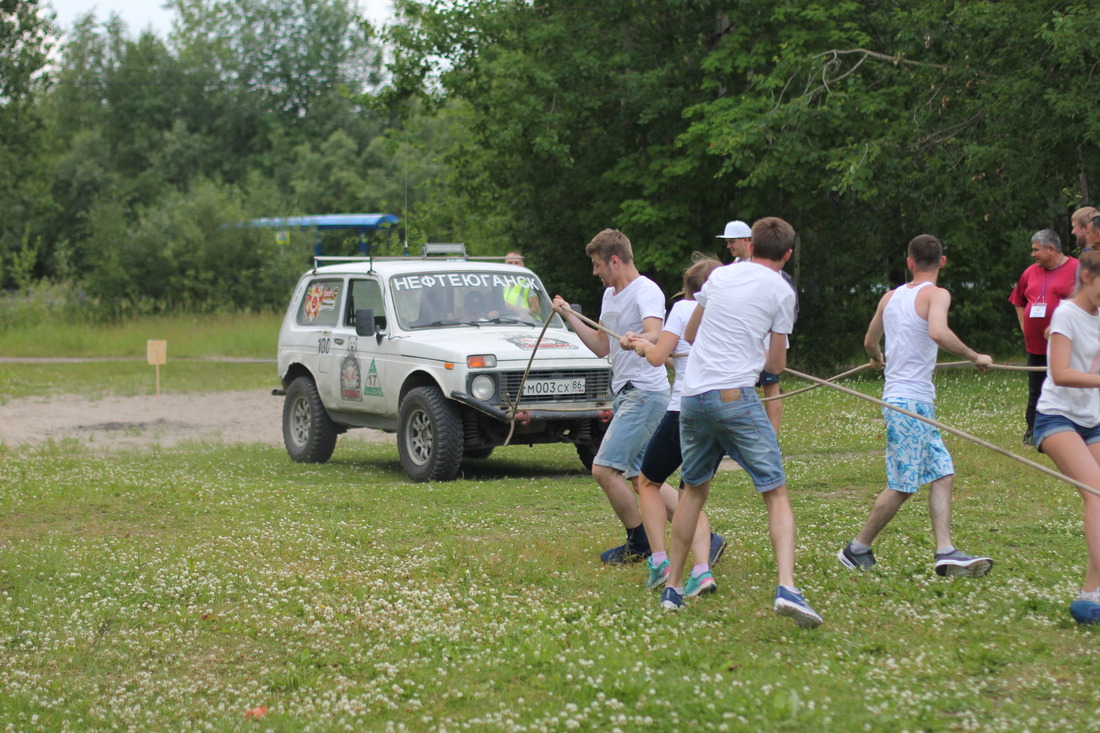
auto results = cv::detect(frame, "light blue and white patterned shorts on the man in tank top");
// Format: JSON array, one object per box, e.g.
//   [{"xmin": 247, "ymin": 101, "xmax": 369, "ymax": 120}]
[{"xmin": 882, "ymin": 397, "xmax": 955, "ymax": 494}]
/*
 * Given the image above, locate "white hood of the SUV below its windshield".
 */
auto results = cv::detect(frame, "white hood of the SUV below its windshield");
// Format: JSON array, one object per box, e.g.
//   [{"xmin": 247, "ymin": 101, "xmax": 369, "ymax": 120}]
[{"xmin": 399, "ymin": 326, "xmax": 606, "ymax": 365}]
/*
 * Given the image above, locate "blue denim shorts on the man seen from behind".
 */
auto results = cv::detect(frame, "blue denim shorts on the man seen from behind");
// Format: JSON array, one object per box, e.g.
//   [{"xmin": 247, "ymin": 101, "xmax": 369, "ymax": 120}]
[{"xmin": 680, "ymin": 387, "xmax": 787, "ymax": 492}]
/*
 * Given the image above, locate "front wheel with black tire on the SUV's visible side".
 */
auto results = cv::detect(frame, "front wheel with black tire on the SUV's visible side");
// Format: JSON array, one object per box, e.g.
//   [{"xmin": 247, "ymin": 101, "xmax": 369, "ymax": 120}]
[{"xmin": 397, "ymin": 386, "xmax": 462, "ymax": 481}]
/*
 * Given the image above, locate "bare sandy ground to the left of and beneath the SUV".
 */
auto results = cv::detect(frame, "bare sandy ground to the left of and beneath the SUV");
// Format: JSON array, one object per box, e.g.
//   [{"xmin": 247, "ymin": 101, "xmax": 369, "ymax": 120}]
[{"xmin": 0, "ymin": 390, "xmax": 394, "ymax": 449}]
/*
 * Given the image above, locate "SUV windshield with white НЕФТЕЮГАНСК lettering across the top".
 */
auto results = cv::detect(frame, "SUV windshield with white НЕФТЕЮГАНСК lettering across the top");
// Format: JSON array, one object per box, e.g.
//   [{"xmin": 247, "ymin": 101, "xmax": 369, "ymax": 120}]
[{"xmin": 389, "ymin": 269, "xmax": 564, "ymax": 329}]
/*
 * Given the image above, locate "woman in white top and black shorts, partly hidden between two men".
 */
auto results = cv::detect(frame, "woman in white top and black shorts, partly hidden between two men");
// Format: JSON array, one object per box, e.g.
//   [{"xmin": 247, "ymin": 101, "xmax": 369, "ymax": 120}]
[{"xmin": 634, "ymin": 254, "xmax": 726, "ymax": 598}]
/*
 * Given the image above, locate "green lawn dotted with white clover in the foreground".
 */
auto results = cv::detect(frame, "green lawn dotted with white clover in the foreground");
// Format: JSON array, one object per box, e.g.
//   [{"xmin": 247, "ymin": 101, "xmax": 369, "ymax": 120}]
[{"xmin": 0, "ymin": 370, "xmax": 1100, "ymax": 731}]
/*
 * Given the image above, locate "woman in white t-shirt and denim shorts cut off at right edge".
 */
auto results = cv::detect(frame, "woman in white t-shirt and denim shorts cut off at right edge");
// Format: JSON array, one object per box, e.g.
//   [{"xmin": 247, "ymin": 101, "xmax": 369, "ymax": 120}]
[{"xmin": 1034, "ymin": 251, "xmax": 1100, "ymax": 624}]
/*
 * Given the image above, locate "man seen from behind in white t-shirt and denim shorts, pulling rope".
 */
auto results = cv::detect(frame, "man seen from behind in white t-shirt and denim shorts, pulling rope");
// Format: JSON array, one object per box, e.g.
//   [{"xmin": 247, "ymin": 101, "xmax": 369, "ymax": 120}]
[{"xmin": 661, "ymin": 217, "xmax": 822, "ymax": 628}]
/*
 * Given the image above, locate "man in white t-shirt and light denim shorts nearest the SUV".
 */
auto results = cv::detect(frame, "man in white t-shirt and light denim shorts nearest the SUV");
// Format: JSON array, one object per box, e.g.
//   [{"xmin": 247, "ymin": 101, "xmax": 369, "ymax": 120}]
[{"xmin": 553, "ymin": 229, "xmax": 669, "ymax": 565}]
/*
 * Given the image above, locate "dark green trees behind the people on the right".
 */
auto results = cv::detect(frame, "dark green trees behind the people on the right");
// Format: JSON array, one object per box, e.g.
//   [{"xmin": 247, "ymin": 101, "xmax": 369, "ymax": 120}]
[{"xmin": 387, "ymin": 0, "xmax": 1100, "ymax": 361}]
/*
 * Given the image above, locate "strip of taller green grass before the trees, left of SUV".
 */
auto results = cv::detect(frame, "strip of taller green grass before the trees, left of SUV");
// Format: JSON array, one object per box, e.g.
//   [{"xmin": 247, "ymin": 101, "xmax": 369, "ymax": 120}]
[{"xmin": 0, "ymin": 313, "xmax": 283, "ymax": 361}]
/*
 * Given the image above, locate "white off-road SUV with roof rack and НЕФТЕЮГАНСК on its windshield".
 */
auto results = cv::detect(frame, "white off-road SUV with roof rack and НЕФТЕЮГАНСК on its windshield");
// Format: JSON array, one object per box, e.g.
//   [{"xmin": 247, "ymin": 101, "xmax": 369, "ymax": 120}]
[{"xmin": 278, "ymin": 250, "xmax": 612, "ymax": 481}]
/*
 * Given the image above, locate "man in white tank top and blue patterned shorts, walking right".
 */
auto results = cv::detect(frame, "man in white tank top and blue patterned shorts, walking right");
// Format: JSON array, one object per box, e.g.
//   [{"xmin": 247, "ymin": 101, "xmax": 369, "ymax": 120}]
[{"xmin": 837, "ymin": 234, "xmax": 993, "ymax": 578}]
